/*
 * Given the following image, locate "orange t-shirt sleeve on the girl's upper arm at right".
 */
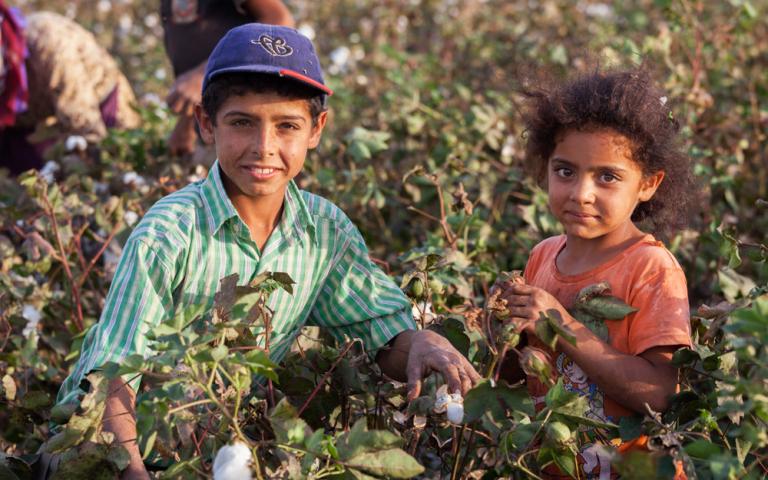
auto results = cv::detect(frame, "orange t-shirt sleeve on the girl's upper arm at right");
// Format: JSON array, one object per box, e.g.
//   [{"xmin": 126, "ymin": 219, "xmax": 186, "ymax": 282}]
[{"xmin": 628, "ymin": 268, "xmax": 691, "ymax": 355}]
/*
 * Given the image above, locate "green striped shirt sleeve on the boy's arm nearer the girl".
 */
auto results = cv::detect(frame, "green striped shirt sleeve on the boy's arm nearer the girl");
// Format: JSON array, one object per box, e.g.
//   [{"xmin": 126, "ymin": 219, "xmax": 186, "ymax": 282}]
[{"xmin": 309, "ymin": 226, "xmax": 416, "ymax": 356}]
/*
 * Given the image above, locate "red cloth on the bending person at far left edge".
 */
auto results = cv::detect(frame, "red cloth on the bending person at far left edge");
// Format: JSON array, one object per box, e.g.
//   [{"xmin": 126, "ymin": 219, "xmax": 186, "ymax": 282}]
[{"xmin": 0, "ymin": 0, "xmax": 29, "ymax": 130}]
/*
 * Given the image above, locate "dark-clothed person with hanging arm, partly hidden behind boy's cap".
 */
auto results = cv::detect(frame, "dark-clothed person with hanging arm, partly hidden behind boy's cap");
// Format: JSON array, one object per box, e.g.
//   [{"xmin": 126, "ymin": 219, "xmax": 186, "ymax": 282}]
[{"xmin": 160, "ymin": 0, "xmax": 294, "ymax": 155}]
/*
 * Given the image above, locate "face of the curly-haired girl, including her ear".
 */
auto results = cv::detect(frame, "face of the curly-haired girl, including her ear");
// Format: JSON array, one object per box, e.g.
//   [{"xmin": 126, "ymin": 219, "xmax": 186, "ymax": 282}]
[{"xmin": 547, "ymin": 129, "xmax": 664, "ymax": 244}]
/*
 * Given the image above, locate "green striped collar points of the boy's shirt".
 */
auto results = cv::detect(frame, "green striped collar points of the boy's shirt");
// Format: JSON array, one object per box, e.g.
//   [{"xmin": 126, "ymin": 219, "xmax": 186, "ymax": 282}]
[{"xmin": 200, "ymin": 160, "xmax": 317, "ymax": 242}]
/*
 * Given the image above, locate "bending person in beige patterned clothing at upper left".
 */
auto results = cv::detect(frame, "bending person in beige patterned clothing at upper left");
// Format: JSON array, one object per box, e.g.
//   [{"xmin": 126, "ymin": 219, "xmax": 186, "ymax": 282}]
[{"xmin": 0, "ymin": 6, "xmax": 140, "ymax": 174}]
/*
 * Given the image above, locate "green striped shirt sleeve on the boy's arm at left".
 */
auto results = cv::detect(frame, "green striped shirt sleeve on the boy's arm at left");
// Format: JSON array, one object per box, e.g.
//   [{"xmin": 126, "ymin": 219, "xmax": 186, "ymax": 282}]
[{"xmin": 57, "ymin": 238, "xmax": 173, "ymax": 404}]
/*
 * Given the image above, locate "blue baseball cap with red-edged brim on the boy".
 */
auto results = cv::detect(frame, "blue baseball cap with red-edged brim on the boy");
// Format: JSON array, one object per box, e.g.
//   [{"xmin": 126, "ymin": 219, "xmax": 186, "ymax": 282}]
[{"xmin": 203, "ymin": 23, "xmax": 333, "ymax": 95}]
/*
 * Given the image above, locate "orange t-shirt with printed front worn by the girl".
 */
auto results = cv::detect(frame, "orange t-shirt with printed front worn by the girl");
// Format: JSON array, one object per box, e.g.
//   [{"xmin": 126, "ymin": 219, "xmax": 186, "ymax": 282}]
[{"xmin": 524, "ymin": 235, "xmax": 691, "ymax": 479}]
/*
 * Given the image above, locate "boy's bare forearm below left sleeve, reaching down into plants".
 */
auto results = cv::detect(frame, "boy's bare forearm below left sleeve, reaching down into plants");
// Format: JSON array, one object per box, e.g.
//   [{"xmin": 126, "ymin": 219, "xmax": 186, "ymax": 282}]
[{"xmin": 102, "ymin": 377, "xmax": 149, "ymax": 480}]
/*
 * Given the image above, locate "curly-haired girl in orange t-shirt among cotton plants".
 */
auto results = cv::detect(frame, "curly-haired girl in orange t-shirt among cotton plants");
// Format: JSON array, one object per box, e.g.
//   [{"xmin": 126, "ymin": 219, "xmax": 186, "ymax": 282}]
[{"xmin": 502, "ymin": 68, "xmax": 695, "ymax": 479}]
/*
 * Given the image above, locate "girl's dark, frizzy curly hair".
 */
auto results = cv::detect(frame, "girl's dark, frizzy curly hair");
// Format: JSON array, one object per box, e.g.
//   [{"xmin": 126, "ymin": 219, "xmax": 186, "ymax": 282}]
[{"xmin": 524, "ymin": 67, "xmax": 697, "ymax": 237}]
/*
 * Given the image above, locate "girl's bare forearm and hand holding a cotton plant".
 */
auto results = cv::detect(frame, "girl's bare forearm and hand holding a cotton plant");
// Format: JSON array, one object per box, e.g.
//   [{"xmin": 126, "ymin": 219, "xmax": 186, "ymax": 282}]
[{"xmin": 502, "ymin": 284, "xmax": 678, "ymax": 413}]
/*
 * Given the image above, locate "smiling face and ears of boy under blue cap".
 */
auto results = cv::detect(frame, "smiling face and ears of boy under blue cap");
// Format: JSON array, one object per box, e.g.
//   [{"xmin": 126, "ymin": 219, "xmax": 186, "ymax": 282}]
[{"xmin": 196, "ymin": 92, "xmax": 327, "ymax": 199}]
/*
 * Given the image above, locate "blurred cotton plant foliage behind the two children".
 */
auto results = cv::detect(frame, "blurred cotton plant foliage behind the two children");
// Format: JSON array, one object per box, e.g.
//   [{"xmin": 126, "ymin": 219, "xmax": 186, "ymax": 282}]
[{"xmin": 0, "ymin": 0, "xmax": 768, "ymax": 478}]
